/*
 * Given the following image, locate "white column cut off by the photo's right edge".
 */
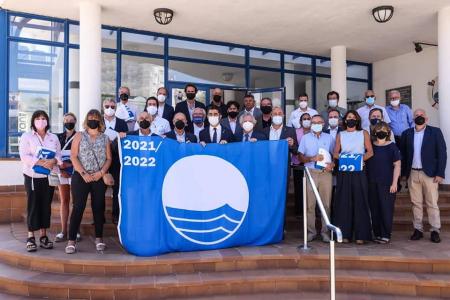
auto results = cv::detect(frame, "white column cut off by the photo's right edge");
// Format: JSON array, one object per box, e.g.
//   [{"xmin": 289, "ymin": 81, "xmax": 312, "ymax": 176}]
[{"xmin": 438, "ymin": 6, "xmax": 450, "ymax": 184}]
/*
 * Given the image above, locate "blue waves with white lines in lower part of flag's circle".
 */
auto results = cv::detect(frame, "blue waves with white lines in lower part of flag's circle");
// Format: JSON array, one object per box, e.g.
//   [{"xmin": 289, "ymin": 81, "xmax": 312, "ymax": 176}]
[{"xmin": 166, "ymin": 204, "xmax": 245, "ymax": 243}]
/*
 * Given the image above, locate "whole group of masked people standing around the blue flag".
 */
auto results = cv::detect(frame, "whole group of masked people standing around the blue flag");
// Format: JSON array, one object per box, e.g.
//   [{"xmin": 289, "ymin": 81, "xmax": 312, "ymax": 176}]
[{"xmin": 19, "ymin": 84, "xmax": 446, "ymax": 254}]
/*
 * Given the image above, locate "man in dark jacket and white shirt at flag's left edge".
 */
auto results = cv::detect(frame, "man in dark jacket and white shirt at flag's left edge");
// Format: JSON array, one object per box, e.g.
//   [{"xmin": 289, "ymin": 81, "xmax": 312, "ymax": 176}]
[{"xmin": 103, "ymin": 99, "xmax": 128, "ymax": 224}]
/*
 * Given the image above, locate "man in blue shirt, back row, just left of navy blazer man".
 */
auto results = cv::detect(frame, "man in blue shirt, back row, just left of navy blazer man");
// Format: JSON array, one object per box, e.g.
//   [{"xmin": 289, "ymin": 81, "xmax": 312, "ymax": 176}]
[{"xmin": 386, "ymin": 90, "xmax": 414, "ymax": 145}]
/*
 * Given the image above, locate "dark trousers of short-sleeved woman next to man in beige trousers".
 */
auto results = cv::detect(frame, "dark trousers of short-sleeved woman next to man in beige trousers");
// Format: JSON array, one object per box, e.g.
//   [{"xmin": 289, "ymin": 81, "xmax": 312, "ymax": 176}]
[{"xmin": 369, "ymin": 182, "xmax": 396, "ymax": 239}]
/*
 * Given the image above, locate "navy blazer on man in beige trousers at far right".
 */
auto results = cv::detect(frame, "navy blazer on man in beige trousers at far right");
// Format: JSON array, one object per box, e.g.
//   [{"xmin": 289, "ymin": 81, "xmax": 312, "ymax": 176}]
[{"xmin": 400, "ymin": 125, "xmax": 447, "ymax": 178}]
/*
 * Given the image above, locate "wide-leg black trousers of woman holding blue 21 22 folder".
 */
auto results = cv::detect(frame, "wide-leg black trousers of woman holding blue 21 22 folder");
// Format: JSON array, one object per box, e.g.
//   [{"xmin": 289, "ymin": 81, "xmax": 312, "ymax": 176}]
[{"xmin": 333, "ymin": 171, "xmax": 372, "ymax": 241}]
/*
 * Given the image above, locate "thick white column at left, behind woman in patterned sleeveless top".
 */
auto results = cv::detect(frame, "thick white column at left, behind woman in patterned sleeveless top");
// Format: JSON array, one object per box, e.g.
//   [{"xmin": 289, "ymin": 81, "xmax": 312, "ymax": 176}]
[{"xmin": 79, "ymin": 0, "xmax": 102, "ymax": 126}]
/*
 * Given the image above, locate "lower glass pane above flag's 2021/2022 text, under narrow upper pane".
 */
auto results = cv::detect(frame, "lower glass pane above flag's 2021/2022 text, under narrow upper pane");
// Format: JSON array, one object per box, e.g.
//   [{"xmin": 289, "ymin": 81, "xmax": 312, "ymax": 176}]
[{"xmin": 122, "ymin": 55, "xmax": 164, "ymax": 110}]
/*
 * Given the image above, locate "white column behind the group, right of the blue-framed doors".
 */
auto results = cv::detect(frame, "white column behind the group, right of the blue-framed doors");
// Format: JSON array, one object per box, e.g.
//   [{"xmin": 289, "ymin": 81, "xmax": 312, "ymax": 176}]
[{"xmin": 331, "ymin": 46, "xmax": 347, "ymax": 108}]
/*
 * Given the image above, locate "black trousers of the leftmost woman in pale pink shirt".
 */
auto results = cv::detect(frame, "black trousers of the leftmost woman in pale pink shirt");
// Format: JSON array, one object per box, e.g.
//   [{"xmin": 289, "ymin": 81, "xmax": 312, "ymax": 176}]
[{"xmin": 23, "ymin": 174, "xmax": 55, "ymax": 231}]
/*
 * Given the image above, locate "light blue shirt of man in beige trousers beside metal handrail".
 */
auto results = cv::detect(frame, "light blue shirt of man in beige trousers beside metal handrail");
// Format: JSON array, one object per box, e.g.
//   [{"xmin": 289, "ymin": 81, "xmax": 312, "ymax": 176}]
[{"xmin": 298, "ymin": 132, "xmax": 334, "ymax": 168}]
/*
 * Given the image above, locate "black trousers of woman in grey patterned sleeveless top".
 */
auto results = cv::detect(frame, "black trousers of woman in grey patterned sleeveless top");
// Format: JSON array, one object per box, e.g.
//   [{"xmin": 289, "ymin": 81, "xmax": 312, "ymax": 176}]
[{"xmin": 69, "ymin": 172, "xmax": 106, "ymax": 241}]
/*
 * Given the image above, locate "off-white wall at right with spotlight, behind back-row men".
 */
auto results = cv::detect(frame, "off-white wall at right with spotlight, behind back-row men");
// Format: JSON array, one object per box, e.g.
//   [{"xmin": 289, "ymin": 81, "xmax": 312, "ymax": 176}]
[{"xmin": 373, "ymin": 44, "xmax": 439, "ymax": 126}]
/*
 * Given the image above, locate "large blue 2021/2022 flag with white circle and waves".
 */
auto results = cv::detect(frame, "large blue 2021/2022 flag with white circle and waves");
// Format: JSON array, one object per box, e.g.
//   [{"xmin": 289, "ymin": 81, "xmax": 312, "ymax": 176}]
[{"xmin": 119, "ymin": 136, "xmax": 288, "ymax": 256}]
